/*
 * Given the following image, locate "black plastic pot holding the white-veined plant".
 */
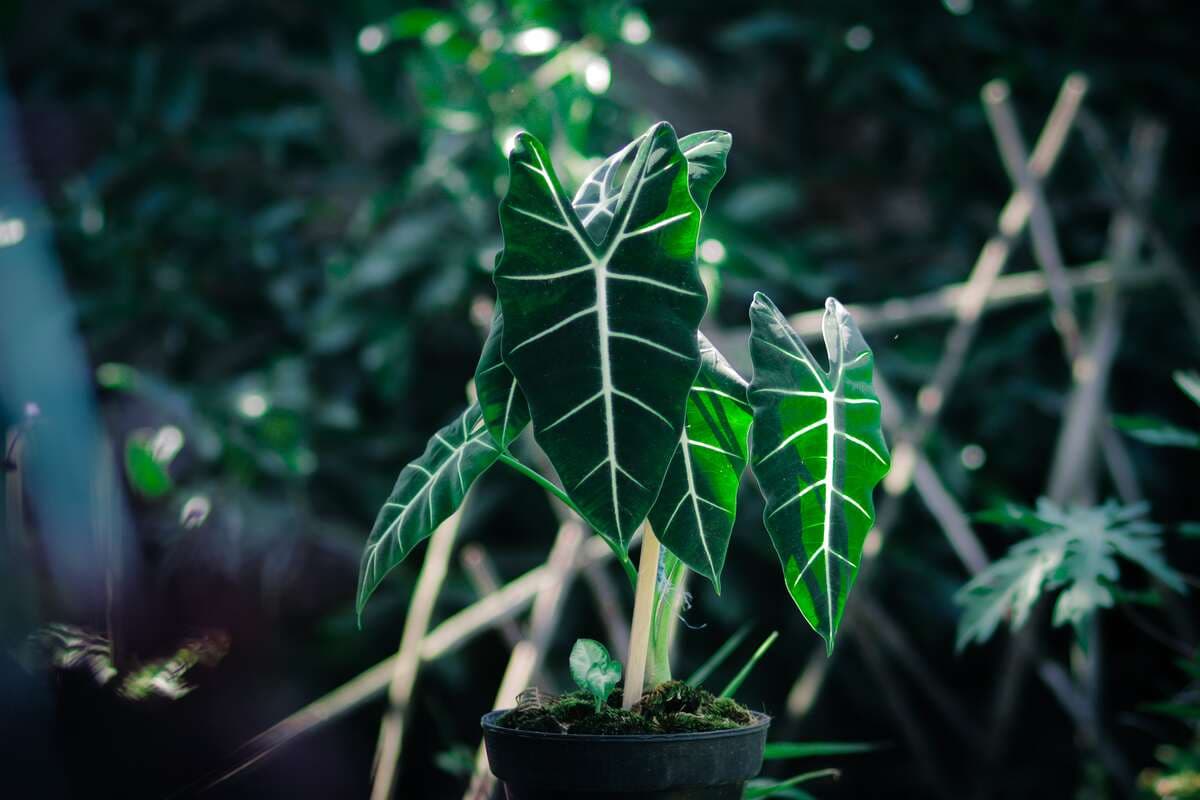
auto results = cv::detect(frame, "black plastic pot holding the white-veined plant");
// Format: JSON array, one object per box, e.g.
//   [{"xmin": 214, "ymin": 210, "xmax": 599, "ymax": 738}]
[{"xmin": 482, "ymin": 710, "xmax": 770, "ymax": 800}]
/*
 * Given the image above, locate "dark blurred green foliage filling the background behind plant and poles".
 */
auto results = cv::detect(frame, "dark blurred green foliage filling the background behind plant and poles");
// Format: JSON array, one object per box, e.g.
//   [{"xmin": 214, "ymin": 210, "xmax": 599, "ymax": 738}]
[{"xmin": 0, "ymin": 0, "xmax": 1200, "ymax": 798}]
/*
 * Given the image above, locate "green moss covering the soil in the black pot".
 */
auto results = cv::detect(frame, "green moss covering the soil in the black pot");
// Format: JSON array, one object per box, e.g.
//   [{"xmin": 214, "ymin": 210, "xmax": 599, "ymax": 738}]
[{"xmin": 500, "ymin": 680, "xmax": 754, "ymax": 735}]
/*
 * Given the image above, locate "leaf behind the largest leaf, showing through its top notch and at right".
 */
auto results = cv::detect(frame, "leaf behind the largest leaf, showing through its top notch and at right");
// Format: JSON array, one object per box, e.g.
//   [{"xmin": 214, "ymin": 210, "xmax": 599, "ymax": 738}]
[{"xmin": 571, "ymin": 131, "xmax": 733, "ymax": 242}]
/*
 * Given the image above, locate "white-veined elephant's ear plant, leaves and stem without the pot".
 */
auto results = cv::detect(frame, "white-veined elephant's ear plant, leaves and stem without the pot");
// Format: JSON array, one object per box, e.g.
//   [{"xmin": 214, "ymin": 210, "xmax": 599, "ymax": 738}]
[{"xmin": 358, "ymin": 122, "xmax": 889, "ymax": 708}]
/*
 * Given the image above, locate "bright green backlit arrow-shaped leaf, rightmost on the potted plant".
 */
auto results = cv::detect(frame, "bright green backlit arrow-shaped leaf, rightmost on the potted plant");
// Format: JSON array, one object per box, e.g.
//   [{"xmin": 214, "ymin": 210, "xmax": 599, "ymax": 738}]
[{"xmin": 749, "ymin": 294, "xmax": 889, "ymax": 650}]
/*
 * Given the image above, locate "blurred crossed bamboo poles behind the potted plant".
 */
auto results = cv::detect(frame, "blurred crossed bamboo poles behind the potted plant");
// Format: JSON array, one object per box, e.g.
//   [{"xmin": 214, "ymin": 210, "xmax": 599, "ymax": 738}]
[{"xmin": 180, "ymin": 74, "xmax": 1200, "ymax": 800}]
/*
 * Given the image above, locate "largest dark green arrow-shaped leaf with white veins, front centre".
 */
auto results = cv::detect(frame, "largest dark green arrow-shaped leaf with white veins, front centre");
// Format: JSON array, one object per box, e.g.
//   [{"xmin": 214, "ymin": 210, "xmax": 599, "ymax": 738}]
[{"xmin": 496, "ymin": 124, "xmax": 706, "ymax": 549}]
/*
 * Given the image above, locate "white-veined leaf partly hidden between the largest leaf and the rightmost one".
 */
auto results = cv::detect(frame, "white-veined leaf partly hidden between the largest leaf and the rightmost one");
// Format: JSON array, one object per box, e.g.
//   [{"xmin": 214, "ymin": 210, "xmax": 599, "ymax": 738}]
[{"xmin": 649, "ymin": 336, "xmax": 751, "ymax": 594}]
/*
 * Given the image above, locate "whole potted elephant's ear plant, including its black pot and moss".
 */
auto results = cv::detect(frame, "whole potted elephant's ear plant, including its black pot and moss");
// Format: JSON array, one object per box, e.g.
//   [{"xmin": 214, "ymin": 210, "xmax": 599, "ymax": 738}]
[{"xmin": 358, "ymin": 122, "xmax": 889, "ymax": 800}]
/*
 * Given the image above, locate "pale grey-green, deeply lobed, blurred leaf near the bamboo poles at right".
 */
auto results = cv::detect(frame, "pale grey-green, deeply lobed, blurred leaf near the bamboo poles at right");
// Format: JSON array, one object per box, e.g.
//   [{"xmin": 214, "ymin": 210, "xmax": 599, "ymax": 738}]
[{"xmin": 955, "ymin": 499, "xmax": 1184, "ymax": 649}]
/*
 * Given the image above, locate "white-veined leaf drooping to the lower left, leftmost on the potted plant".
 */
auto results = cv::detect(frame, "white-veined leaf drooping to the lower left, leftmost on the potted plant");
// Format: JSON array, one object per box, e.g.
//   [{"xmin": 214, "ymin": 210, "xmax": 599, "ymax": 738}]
[{"xmin": 358, "ymin": 404, "xmax": 500, "ymax": 618}]
